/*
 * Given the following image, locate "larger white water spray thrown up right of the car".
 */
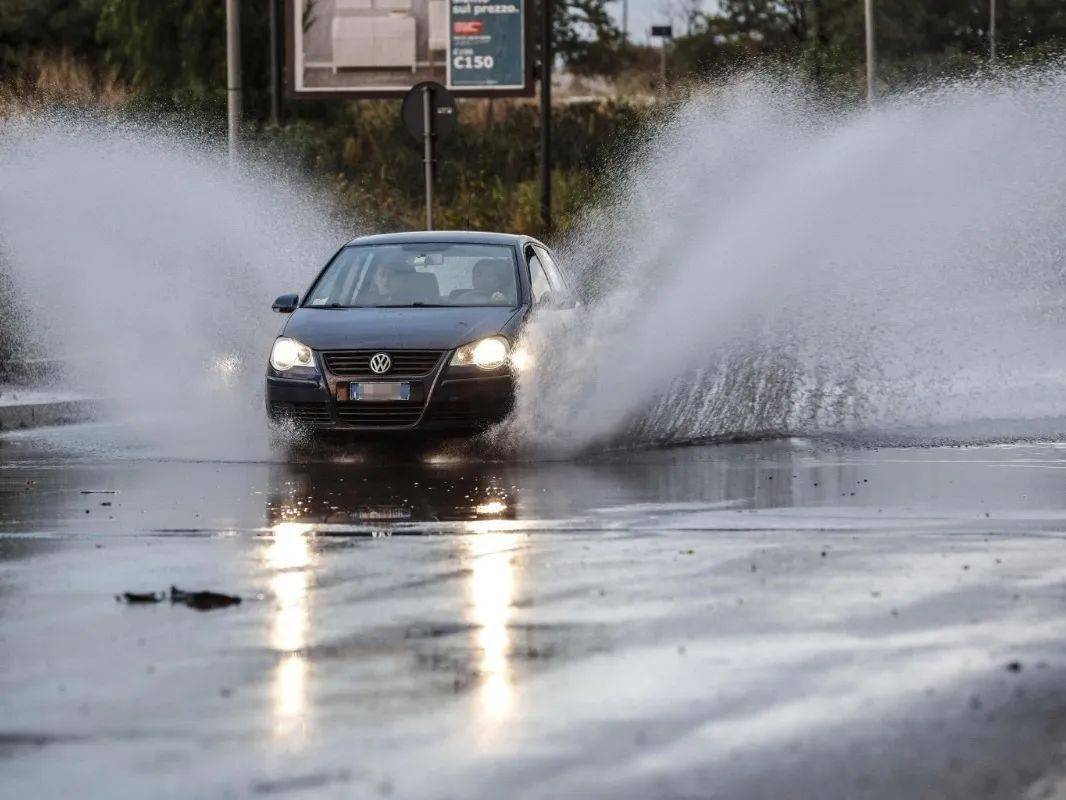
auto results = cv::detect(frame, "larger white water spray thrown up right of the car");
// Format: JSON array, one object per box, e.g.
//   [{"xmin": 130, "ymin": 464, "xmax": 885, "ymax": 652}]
[{"xmin": 502, "ymin": 68, "xmax": 1066, "ymax": 451}]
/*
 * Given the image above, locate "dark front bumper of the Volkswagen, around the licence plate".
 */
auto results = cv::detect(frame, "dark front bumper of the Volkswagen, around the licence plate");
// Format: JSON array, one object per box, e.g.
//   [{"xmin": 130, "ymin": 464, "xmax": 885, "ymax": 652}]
[{"xmin": 267, "ymin": 352, "xmax": 515, "ymax": 433}]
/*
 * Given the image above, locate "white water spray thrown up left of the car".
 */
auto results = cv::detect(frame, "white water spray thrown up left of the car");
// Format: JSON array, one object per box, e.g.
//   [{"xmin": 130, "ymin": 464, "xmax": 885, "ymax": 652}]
[{"xmin": 0, "ymin": 115, "xmax": 354, "ymax": 458}]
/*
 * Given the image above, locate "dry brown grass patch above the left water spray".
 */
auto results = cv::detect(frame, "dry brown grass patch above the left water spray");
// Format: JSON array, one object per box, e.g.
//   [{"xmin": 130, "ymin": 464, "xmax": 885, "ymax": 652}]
[{"xmin": 0, "ymin": 52, "xmax": 132, "ymax": 116}]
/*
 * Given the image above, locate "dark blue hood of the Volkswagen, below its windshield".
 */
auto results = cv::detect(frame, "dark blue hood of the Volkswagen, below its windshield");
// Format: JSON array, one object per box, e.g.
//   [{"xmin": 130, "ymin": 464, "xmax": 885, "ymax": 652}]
[{"xmin": 284, "ymin": 307, "xmax": 518, "ymax": 350}]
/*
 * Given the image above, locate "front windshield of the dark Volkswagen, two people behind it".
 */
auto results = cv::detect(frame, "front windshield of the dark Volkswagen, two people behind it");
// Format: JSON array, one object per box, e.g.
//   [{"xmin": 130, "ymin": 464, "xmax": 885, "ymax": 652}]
[{"xmin": 304, "ymin": 242, "xmax": 518, "ymax": 308}]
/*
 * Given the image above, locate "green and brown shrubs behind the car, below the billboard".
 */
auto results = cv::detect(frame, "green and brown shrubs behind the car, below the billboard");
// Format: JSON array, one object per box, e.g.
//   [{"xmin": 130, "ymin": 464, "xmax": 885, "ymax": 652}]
[{"xmin": 253, "ymin": 100, "xmax": 649, "ymax": 236}]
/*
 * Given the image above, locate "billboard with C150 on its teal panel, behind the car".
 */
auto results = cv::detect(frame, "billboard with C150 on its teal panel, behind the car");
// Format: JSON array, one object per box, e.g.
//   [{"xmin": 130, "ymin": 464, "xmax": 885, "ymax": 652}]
[{"xmin": 286, "ymin": 0, "xmax": 533, "ymax": 99}]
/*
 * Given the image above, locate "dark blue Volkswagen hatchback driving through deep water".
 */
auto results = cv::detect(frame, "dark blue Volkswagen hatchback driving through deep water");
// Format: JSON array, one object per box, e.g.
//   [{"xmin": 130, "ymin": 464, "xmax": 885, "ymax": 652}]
[{"xmin": 267, "ymin": 231, "xmax": 576, "ymax": 433}]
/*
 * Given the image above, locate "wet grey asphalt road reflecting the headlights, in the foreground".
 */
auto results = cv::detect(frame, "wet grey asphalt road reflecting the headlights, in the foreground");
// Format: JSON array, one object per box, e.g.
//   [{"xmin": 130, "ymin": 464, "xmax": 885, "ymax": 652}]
[{"xmin": 0, "ymin": 426, "xmax": 1066, "ymax": 799}]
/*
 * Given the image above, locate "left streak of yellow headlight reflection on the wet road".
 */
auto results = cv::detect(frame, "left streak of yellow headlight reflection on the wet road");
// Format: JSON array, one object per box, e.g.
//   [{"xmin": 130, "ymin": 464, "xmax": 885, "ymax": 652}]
[{"xmin": 264, "ymin": 523, "xmax": 312, "ymax": 736}]
